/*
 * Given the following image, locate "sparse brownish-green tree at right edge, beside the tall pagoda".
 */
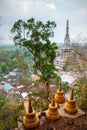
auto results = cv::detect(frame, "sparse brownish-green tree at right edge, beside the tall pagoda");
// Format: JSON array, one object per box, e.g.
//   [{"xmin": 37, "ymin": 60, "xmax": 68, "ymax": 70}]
[{"xmin": 63, "ymin": 43, "xmax": 87, "ymax": 76}]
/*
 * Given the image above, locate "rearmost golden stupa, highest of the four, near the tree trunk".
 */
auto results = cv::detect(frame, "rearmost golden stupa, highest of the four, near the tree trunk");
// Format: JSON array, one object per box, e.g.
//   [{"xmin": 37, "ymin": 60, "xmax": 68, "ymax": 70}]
[{"xmin": 55, "ymin": 81, "xmax": 65, "ymax": 104}]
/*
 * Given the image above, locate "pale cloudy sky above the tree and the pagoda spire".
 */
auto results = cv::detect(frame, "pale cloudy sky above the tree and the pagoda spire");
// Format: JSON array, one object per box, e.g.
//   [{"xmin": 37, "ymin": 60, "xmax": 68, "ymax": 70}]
[{"xmin": 0, "ymin": 0, "xmax": 87, "ymax": 44}]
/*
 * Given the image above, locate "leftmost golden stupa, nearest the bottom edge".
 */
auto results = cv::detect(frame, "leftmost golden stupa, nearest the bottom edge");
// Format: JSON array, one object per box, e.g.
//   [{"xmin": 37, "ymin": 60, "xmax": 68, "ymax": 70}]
[{"xmin": 23, "ymin": 99, "xmax": 39, "ymax": 129}]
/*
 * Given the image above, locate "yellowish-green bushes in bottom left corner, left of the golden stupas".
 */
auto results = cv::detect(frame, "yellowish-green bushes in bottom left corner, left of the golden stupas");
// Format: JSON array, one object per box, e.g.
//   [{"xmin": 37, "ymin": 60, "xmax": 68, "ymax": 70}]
[{"xmin": 0, "ymin": 95, "xmax": 24, "ymax": 130}]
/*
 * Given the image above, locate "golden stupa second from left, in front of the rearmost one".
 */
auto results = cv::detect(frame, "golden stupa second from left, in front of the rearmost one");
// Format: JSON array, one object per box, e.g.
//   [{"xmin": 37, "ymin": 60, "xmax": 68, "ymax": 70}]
[{"xmin": 46, "ymin": 95, "xmax": 60, "ymax": 121}]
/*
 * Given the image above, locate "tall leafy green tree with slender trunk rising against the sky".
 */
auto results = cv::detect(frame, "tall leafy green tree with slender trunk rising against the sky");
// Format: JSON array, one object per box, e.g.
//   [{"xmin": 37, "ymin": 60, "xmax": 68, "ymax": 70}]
[{"xmin": 11, "ymin": 18, "xmax": 58, "ymax": 97}]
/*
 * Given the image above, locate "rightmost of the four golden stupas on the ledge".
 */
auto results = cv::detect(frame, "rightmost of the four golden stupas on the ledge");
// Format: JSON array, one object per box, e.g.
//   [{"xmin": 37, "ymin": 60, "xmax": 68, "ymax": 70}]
[{"xmin": 64, "ymin": 89, "xmax": 78, "ymax": 114}]
